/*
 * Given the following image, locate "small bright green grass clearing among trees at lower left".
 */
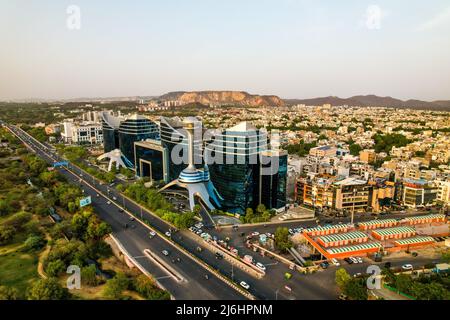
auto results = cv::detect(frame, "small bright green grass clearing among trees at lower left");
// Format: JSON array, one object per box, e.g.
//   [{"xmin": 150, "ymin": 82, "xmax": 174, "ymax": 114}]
[{"xmin": 0, "ymin": 252, "xmax": 39, "ymax": 296}]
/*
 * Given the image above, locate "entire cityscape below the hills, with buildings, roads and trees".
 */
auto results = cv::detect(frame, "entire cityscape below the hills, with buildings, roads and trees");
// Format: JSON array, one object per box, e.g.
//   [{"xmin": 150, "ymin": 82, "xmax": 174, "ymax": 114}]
[{"xmin": 0, "ymin": 98, "xmax": 450, "ymax": 300}]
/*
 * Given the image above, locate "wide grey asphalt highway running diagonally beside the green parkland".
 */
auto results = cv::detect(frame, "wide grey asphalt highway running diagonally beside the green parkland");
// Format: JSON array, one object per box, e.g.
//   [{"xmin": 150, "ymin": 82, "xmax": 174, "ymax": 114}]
[{"xmin": 5, "ymin": 127, "xmax": 244, "ymax": 300}]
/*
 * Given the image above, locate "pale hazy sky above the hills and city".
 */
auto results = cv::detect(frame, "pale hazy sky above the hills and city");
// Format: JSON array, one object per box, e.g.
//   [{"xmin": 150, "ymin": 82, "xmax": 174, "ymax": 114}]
[{"xmin": 0, "ymin": 0, "xmax": 450, "ymax": 100}]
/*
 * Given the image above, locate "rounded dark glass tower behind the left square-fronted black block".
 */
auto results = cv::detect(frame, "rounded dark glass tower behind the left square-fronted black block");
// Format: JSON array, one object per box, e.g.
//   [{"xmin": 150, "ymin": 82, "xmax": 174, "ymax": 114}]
[{"xmin": 119, "ymin": 114, "xmax": 159, "ymax": 165}]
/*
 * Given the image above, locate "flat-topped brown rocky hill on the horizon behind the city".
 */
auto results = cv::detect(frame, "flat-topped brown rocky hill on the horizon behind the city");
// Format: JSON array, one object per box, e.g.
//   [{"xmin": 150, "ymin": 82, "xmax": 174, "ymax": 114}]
[{"xmin": 159, "ymin": 91, "xmax": 285, "ymax": 107}]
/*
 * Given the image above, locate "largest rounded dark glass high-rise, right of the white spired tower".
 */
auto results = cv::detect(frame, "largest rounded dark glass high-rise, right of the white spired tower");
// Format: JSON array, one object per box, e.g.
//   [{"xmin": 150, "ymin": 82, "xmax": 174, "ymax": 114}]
[{"xmin": 205, "ymin": 122, "xmax": 287, "ymax": 213}]
